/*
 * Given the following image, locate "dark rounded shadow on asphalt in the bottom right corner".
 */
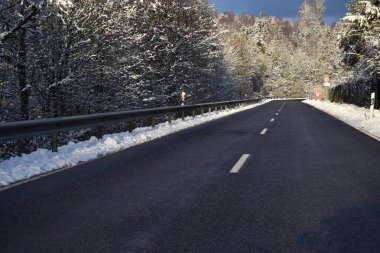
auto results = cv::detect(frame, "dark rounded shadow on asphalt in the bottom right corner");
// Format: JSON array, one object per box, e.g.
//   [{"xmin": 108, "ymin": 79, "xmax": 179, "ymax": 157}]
[{"xmin": 298, "ymin": 204, "xmax": 380, "ymax": 253}]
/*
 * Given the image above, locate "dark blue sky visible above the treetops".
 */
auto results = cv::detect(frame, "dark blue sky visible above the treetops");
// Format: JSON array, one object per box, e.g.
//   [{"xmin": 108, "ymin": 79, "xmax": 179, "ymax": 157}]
[{"xmin": 210, "ymin": 0, "xmax": 350, "ymax": 23}]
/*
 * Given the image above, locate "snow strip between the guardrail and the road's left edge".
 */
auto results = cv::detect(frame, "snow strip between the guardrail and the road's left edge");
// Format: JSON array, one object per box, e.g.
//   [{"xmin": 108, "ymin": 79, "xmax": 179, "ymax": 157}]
[{"xmin": 0, "ymin": 100, "xmax": 270, "ymax": 187}]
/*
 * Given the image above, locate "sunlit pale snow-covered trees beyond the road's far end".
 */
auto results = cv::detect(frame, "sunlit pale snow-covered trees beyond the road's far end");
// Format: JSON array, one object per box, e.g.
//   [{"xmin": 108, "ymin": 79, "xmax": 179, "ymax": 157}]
[{"xmin": 215, "ymin": 6, "xmax": 342, "ymax": 96}]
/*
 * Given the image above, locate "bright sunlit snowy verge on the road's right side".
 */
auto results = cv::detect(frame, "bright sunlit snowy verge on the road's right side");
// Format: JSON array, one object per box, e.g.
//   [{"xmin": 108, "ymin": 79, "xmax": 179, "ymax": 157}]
[{"xmin": 304, "ymin": 100, "xmax": 380, "ymax": 140}]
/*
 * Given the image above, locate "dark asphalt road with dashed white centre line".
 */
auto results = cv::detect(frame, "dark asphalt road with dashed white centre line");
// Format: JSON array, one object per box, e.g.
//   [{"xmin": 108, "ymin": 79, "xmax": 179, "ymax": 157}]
[{"xmin": 0, "ymin": 101, "xmax": 380, "ymax": 253}]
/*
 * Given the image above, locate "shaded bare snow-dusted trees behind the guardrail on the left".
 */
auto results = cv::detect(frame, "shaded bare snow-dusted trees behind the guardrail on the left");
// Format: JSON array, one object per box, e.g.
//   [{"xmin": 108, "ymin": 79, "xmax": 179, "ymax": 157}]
[{"xmin": 0, "ymin": 0, "xmax": 236, "ymax": 120}]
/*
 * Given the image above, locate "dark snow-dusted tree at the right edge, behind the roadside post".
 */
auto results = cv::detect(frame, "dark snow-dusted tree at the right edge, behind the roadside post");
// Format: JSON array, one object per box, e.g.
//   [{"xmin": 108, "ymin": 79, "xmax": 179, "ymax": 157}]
[{"xmin": 340, "ymin": 0, "xmax": 380, "ymax": 106}]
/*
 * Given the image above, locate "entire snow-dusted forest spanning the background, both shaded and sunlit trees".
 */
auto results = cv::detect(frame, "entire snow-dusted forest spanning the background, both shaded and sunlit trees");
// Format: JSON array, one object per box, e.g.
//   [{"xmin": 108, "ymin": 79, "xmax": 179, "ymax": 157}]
[{"xmin": 0, "ymin": 0, "xmax": 380, "ymax": 156}]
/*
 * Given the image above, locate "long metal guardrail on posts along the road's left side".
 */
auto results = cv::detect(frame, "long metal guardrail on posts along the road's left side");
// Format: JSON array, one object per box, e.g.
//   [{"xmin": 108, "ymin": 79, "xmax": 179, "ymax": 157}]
[{"xmin": 0, "ymin": 98, "xmax": 262, "ymax": 152}]
